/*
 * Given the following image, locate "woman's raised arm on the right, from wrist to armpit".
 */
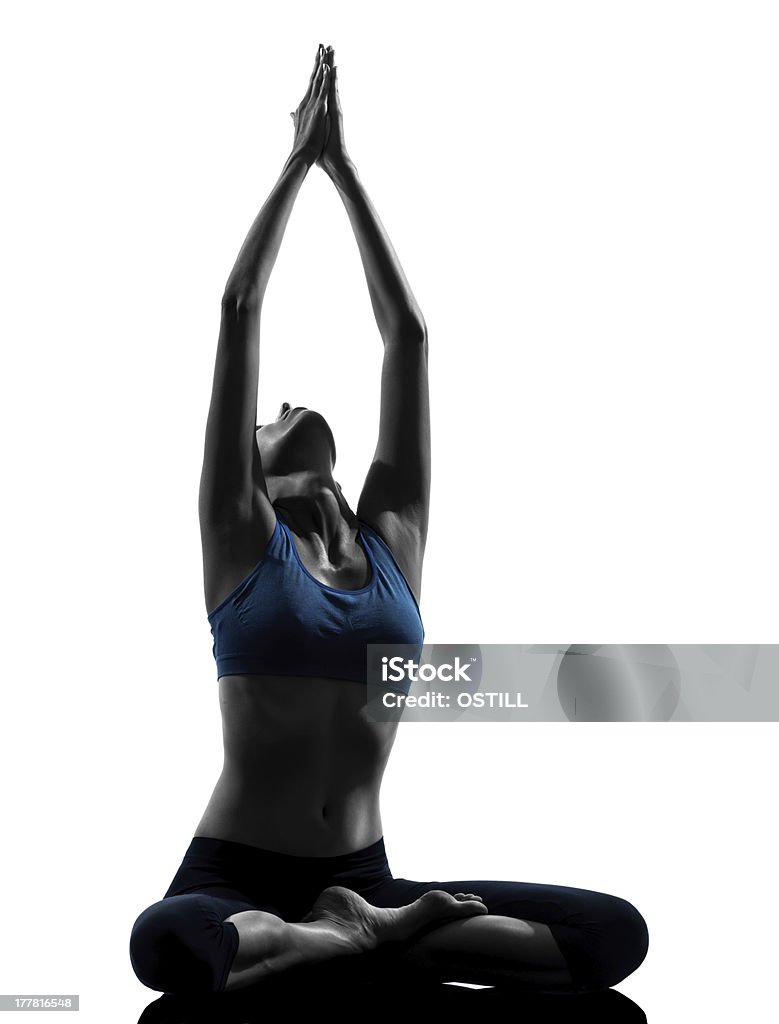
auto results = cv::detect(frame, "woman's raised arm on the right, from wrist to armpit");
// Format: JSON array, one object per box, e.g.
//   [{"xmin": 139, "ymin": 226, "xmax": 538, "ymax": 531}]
[{"xmin": 330, "ymin": 160, "xmax": 430, "ymax": 600}]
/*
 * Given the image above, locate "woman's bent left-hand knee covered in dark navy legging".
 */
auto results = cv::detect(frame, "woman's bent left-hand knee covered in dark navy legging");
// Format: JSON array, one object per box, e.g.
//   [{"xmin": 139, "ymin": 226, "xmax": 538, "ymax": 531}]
[{"xmin": 130, "ymin": 893, "xmax": 239, "ymax": 994}]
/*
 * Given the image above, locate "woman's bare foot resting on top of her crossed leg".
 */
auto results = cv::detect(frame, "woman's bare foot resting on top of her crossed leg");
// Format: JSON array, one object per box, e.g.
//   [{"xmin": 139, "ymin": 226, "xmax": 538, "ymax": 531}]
[{"xmin": 301, "ymin": 886, "xmax": 488, "ymax": 952}]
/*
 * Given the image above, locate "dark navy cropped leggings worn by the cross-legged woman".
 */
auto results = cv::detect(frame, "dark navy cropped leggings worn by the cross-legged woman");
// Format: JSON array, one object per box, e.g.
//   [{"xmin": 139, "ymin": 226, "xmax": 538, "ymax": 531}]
[{"xmin": 130, "ymin": 837, "xmax": 648, "ymax": 995}]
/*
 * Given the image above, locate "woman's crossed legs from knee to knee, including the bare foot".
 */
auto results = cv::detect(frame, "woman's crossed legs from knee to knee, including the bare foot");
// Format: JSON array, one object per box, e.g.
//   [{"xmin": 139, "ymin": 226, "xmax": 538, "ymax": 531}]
[{"xmin": 130, "ymin": 878, "xmax": 648, "ymax": 992}]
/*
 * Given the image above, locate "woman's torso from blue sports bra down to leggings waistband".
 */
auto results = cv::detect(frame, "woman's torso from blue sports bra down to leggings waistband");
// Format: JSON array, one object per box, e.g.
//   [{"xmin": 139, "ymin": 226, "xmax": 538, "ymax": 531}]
[{"xmin": 194, "ymin": 516, "xmax": 424, "ymax": 856}]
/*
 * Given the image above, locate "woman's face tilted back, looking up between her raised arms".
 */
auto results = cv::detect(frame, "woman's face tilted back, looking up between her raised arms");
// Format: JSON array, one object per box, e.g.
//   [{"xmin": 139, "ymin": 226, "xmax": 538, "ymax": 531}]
[{"xmin": 256, "ymin": 401, "xmax": 336, "ymax": 476}]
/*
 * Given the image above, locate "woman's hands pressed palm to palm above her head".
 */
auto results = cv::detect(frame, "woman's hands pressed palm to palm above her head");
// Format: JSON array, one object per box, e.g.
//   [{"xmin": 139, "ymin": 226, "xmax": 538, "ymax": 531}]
[{"xmin": 290, "ymin": 43, "xmax": 349, "ymax": 174}]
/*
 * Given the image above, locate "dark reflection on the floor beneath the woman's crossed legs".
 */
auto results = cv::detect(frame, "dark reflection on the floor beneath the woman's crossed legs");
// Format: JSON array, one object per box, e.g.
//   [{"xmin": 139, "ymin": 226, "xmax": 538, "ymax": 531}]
[{"xmin": 138, "ymin": 982, "xmax": 646, "ymax": 1024}]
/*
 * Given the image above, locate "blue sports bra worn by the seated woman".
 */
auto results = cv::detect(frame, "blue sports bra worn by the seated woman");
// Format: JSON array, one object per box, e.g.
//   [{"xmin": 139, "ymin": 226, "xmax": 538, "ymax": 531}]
[{"xmin": 208, "ymin": 512, "xmax": 425, "ymax": 683}]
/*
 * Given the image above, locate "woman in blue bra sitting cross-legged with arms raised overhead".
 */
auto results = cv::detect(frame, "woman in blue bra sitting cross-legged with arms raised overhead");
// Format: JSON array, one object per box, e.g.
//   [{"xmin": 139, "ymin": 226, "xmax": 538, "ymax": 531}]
[{"xmin": 130, "ymin": 46, "xmax": 647, "ymax": 993}]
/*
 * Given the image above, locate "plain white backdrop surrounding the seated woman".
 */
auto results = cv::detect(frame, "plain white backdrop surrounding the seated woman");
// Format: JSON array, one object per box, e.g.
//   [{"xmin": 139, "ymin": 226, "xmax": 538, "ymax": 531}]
[{"xmin": 0, "ymin": 0, "xmax": 779, "ymax": 1024}]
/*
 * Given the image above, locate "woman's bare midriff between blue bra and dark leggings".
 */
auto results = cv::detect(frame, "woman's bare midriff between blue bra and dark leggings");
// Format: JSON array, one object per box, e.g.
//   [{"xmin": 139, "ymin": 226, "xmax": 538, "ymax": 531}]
[{"xmin": 194, "ymin": 676, "xmax": 396, "ymax": 857}]
